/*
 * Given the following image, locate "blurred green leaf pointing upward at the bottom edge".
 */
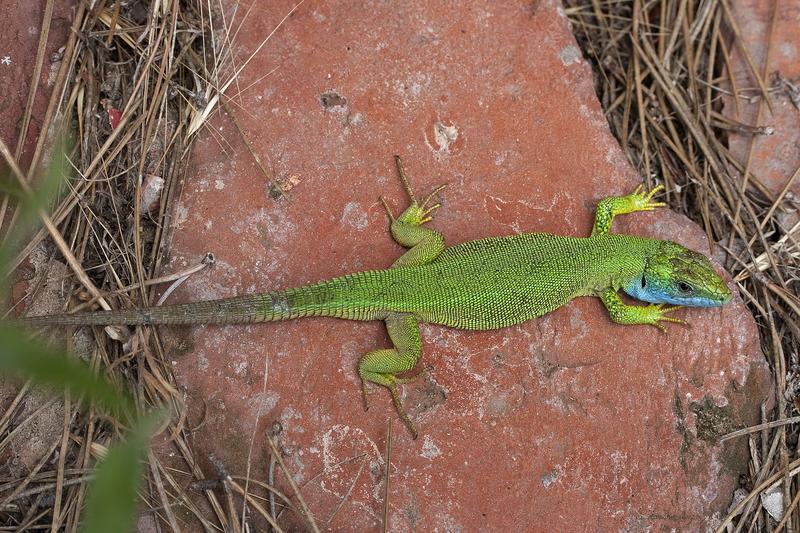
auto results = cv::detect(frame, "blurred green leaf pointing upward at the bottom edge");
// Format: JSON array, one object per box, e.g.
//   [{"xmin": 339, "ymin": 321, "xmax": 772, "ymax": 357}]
[{"xmin": 81, "ymin": 411, "xmax": 164, "ymax": 533}]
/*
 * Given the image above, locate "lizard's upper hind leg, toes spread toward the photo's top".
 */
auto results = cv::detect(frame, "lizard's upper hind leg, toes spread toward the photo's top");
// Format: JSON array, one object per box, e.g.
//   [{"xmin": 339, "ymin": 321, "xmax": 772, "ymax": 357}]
[{"xmin": 381, "ymin": 155, "xmax": 445, "ymax": 267}]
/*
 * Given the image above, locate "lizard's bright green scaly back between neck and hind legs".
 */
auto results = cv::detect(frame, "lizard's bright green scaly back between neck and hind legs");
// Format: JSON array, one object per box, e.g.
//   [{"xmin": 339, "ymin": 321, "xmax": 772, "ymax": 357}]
[{"xmin": 374, "ymin": 233, "xmax": 657, "ymax": 330}]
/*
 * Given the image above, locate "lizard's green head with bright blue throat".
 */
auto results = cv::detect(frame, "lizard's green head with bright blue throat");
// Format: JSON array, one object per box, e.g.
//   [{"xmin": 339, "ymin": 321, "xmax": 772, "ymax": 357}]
[{"xmin": 623, "ymin": 241, "xmax": 731, "ymax": 307}]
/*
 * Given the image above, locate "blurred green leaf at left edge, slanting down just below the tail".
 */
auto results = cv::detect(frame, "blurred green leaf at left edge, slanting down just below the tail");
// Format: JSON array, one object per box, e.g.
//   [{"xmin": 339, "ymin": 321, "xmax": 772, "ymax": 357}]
[{"xmin": 0, "ymin": 324, "xmax": 136, "ymax": 421}]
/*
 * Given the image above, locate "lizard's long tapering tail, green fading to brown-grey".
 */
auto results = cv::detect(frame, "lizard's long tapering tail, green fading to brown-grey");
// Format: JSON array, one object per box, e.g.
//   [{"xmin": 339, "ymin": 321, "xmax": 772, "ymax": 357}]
[{"xmin": 13, "ymin": 272, "xmax": 378, "ymax": 327}]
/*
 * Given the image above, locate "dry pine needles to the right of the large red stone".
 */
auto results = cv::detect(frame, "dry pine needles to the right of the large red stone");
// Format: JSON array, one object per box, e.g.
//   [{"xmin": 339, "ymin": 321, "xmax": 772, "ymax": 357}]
[{"xmin": 566, "ymin": 0, "xmax": 800, "ymax": 531}]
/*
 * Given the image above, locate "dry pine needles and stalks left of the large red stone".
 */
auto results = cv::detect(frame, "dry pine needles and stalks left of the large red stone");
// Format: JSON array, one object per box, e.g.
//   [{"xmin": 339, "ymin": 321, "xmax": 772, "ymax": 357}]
[{"xmin": 0, "ymin": 0, "xmax": 318, "ymax": 532}]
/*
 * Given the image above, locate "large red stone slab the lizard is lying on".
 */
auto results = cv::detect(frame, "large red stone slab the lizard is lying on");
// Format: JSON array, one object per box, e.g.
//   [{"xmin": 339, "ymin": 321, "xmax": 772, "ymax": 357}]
[{"xmin": 153, "ymin": 1, "xmax": 768, "ymax": 531}]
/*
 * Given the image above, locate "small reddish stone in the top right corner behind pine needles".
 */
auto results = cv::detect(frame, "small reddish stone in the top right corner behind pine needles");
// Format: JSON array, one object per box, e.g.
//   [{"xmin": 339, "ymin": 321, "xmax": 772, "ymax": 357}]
[{"xmin": 725, "ymin": 0, "xmax": 800, "ymax": 196}]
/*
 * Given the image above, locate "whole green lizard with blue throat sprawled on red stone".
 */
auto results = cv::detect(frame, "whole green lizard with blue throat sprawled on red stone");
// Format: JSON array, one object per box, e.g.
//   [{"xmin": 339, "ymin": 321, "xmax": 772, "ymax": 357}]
[{"xmin": 22, "ymin": 156, "xmax": 731, "ymax": 438}]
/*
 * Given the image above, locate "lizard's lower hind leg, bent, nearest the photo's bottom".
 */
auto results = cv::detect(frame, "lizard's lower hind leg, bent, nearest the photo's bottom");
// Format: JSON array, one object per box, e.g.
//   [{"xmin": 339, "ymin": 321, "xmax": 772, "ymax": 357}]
[{"xmin": 358, "ymin": 313, "xmax": 422, "ymax": 439}]
